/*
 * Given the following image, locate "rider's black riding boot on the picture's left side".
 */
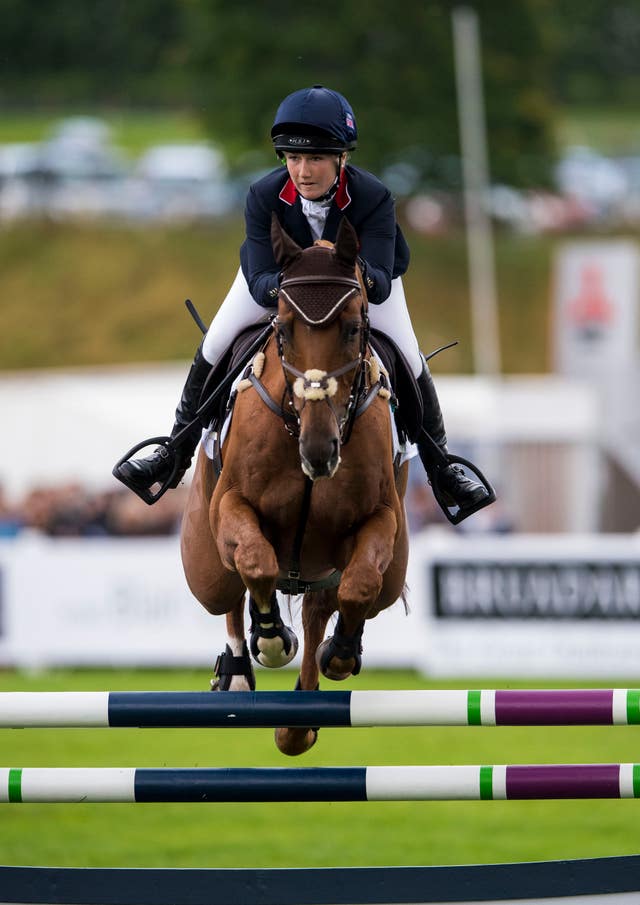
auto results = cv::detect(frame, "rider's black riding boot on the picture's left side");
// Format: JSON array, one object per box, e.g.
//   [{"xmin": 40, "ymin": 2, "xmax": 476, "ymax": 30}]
[{"xmin": 113, "ymin": 344, "xmax": 211, "ymax": 490}]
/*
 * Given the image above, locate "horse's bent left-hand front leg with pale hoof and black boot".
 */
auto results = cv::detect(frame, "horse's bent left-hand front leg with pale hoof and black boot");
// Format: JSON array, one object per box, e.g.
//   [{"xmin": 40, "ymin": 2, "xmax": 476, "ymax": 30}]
[{"xmin": 213, "ymin": 491, "xmax": 298, "ymax": 668}]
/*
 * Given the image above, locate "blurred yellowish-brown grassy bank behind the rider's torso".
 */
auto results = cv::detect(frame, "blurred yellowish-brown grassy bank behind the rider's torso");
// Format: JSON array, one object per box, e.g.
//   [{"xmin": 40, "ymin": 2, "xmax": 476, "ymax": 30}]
[{"xmin": 0, "ymin": 222, "xmax": 555, "ymax": 373}]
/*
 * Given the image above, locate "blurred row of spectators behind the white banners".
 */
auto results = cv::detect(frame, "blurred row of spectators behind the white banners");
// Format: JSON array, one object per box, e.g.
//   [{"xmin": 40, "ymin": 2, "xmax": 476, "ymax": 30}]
[{"xmin": 0, "ymin": 460, "xmax": 513, "ymax": 538}]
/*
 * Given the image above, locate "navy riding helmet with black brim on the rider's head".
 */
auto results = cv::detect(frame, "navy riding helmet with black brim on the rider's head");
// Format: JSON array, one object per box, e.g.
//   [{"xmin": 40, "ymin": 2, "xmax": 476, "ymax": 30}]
[{"xmin": 271, "ymin": 85, "xmax": 358, "ymax": 157}]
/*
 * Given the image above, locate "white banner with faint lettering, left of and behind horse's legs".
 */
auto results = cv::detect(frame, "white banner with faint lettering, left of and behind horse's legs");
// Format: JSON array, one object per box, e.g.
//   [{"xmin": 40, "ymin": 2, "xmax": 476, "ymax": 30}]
[{"xmin": 0, "ymin": 534, "xmax": 420, "ymax": 669}]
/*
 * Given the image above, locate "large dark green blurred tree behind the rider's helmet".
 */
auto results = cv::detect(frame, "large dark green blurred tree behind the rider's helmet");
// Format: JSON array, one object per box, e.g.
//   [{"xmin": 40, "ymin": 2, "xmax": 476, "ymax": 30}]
[{"xmin": 190, "ymin": 0, "xmax": 552, "ymax": 185}]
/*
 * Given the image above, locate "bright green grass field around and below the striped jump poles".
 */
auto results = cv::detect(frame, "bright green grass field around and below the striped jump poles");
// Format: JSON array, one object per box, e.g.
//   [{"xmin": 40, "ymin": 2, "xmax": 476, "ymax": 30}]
[{"xmin": 0, "ymin": 669, "xmax": 640, "ymax": 867}]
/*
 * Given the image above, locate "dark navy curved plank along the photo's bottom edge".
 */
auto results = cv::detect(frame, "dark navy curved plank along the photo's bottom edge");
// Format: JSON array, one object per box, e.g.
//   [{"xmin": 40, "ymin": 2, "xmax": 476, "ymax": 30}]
[{"xmin": 0, "ymin": 855, "xmax": 640, "ymax": 905}]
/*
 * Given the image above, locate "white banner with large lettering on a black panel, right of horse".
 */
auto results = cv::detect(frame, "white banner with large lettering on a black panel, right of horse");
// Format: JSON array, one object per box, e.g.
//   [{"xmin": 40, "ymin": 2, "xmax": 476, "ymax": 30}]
[{"xmin": 409, "ymin": 535, "xmax": 640, "ymax": 678}]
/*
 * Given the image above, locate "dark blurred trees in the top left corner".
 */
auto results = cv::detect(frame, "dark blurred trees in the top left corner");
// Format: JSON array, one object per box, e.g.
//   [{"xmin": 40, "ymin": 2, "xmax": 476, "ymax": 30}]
[{"xmin": 0, "ymin": 0, "xmax": 186, "ymax": 105}]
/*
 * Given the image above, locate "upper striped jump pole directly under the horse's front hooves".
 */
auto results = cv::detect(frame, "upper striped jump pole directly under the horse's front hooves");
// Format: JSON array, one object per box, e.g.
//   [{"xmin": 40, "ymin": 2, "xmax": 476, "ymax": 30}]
[{"xmin": 0, "ymin": 688, "xmax": 640, "ymax": 729}]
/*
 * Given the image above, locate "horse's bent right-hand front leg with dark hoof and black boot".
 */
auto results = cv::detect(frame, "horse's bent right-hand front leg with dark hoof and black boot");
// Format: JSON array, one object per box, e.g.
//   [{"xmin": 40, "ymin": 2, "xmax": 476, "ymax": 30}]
[{"xmin": 316, "ymin": 507, "xmax": 398, "ymax": 681}]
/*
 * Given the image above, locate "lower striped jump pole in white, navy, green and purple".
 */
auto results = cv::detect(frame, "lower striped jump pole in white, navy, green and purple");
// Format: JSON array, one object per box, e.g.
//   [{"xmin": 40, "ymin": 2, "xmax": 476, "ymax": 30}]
[{"xmin": 0, "ymin": 764, "xmax": 640, "ymax": 804}]
